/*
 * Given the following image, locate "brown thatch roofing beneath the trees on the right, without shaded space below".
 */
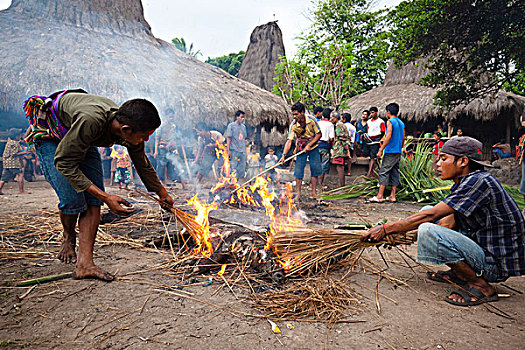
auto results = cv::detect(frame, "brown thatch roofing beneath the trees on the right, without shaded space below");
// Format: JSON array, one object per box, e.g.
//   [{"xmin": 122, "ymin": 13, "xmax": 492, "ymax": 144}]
[{"xmin": 347, "ymin": 61, "xmax": 525, "ymax": 121}]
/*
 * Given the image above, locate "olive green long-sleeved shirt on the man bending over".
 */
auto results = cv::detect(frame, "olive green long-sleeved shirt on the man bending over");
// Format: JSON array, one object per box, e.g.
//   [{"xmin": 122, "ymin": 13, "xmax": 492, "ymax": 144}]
[{"xmin": 55, "ymin": 92, "xmax": 163, "ymax": 192}]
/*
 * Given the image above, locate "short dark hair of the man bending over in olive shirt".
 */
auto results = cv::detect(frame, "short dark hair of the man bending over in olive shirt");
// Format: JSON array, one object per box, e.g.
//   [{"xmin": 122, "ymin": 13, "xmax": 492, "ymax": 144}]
[{"xmin": 115, "ymin": 98, "xmax": 161, "ymax": 131}]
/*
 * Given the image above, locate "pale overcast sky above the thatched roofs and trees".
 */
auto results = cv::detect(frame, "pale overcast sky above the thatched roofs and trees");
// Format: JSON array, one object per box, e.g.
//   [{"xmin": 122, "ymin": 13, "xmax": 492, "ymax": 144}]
[{"xmin": 0, "ymin": 0, "xmax": 401, "ymax": 60}]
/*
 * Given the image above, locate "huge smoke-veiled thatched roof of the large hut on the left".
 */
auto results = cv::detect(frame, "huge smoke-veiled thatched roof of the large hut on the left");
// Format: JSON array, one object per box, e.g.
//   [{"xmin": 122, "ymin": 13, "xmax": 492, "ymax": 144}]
[{"xmin": 0, "ymin": 0, "xmax": 291, "ymax": 145}]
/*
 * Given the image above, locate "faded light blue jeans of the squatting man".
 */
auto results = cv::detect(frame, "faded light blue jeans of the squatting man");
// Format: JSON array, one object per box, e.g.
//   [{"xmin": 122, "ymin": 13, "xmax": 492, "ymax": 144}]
[{"xmin": 417, "ymin": 222, "xmax": 507, "ymax": 282}]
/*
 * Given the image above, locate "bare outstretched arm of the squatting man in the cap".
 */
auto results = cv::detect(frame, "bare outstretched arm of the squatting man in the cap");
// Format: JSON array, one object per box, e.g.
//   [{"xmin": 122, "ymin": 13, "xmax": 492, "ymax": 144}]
[{"xmin": 361, "ymin": 202, "xmax": 454, "ymax": 242}]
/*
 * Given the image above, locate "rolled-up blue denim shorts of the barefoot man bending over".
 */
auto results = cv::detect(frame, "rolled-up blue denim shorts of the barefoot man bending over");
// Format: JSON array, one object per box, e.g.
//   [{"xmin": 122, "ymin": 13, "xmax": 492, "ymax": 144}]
[{"xmin": 35, "ymin": 140, "xmax": 104, "ymax": 214}]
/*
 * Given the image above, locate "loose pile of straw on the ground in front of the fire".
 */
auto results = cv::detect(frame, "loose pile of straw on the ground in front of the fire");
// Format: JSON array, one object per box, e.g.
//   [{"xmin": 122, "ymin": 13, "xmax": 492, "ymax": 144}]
[{"xmin": 250, "ymin": 276, "xmax": 361, "ymax": 323}]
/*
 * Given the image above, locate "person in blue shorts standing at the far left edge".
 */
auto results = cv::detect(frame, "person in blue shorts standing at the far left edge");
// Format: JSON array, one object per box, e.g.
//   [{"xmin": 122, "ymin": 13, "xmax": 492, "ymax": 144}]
[{"xmin": 0, "ymin": 129, "xmax": 24, "ymax": 195}]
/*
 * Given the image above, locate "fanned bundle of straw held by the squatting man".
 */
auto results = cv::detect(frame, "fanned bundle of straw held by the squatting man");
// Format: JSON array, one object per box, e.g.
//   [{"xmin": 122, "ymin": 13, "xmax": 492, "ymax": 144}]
[{"xmin": 273, "ymin": 229, "xmax": 416, "ymax": 276}]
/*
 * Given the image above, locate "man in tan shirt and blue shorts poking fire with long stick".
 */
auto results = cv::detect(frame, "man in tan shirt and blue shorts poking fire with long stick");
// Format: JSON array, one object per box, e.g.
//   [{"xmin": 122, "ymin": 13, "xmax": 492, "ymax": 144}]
[{"xmin": 279, "ymin": 102, "xmax": 321, "ymax": 200}]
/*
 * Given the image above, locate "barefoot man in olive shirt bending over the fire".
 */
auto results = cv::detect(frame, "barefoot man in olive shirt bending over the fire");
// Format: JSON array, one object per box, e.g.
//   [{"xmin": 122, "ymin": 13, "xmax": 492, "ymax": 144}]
[{"xmin": 24, "ymin": 90, "xmax": 173, "ymax": 281}]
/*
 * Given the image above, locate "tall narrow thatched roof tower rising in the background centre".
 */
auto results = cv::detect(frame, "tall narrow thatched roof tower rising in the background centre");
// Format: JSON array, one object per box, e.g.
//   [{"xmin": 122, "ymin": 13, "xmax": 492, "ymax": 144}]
[{"xmin": 237, "ymin": 21, "xmax": 285, "ymax": 91}]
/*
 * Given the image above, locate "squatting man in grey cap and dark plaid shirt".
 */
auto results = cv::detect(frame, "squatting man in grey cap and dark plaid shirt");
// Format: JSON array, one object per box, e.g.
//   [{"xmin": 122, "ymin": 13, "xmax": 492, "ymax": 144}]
[{"xmin": 362, "ymin": 136, "xmax": 525, "ymax": 306}]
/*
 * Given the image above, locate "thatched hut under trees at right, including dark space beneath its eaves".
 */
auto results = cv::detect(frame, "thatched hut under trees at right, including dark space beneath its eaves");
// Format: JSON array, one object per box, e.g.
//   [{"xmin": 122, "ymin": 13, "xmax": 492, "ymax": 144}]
[{"xmin": 347, "ymin": 61, "xmax": 525, "ymax": 150}]
